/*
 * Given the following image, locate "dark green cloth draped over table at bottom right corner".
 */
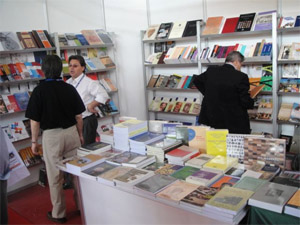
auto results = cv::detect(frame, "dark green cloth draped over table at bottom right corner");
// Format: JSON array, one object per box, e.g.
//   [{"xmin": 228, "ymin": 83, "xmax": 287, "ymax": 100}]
[{"xmin": 248, "ymin": 206, "xmax": 300, "ymax": 225}]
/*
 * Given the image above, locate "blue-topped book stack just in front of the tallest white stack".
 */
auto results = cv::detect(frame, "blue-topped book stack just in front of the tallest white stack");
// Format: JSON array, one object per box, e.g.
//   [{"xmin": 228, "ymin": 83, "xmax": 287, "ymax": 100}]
[{"xmin": 129, "ymin": 132, "xmax": 165, "ymax": 155}]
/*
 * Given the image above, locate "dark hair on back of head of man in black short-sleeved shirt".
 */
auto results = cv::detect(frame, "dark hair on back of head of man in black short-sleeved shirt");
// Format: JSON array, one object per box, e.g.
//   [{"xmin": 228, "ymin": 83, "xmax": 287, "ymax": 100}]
[{"xmin": 42, "ymin": 55, "xmax": 62, "ymax": 79}]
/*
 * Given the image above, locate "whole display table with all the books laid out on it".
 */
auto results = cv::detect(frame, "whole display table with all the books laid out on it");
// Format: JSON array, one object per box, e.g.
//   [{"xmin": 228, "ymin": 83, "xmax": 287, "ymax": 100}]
[{"xmin": 58, "ymin": 119, "xmax": 300, "ymax": 224}]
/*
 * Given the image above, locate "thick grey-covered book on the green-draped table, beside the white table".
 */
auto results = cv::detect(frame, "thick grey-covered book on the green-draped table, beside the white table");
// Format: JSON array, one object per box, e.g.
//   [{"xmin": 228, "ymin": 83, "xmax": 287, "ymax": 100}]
[{"xmin": 248, "ymin": 182, "xmax": 298, "ymax": 213}]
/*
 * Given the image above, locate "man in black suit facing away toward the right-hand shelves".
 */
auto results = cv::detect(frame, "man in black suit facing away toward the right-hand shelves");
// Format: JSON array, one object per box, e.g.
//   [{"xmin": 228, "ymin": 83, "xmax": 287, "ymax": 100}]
[{"xmin": 194, "ymin": 51, "xmax": 254, "ymax": 134}]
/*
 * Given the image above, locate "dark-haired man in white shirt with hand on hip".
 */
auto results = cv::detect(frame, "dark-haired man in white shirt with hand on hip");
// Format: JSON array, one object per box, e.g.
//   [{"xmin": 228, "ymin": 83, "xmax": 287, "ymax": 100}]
[{"xmin": 67, "ymin": 55, "xmax": 110, "ymax": 145}]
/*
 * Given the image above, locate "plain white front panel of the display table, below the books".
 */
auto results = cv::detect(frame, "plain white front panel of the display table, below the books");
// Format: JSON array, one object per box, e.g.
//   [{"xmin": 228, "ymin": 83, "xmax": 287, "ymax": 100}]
[{"xmin": 79, "ymin": 177, "xmax": 246, "ymax": 224}]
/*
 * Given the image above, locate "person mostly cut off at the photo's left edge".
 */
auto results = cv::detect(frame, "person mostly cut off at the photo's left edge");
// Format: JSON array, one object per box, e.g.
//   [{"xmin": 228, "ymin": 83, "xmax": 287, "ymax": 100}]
[{"xmin": 0, "ymin": 127, "xmax": 13, "ymax": 225}]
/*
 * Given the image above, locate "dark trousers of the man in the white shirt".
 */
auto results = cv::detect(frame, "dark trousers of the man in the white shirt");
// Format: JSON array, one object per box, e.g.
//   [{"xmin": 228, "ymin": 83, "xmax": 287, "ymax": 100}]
[{"xmin": 83, "ymin": 114, "xmax": 98, "ymax": 145}]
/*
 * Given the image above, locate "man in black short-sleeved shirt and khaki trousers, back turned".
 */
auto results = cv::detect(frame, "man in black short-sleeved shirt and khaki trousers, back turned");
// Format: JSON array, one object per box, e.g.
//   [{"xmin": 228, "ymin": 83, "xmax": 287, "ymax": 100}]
[{"xmin": 25, "ymin": 55, "xmax": 85, "ymax": 223}]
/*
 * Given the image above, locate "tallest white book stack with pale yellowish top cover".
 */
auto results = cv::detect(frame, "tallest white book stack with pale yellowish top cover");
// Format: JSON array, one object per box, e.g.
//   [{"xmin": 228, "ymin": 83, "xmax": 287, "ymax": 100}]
[{"xmin": 113, "ymin": 120, "xmax": 148, "ymax": 151}]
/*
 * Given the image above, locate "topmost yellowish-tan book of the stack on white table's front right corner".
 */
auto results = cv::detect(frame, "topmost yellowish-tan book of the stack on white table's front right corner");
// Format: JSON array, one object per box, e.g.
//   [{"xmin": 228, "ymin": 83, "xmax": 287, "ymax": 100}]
[{"xmin": 205, "ymin": 187, "xmax": 254, "ymax": 215}]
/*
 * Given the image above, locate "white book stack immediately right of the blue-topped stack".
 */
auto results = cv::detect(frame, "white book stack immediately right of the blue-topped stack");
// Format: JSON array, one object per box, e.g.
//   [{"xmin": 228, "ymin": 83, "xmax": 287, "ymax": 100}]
[{"xmin": 146, "ymin": 139, "xmax": 182, "ymax": 163}]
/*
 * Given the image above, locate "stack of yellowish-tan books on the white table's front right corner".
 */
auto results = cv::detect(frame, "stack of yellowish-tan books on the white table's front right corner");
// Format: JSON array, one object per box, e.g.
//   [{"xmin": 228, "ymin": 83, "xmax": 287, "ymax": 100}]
[{"xmin": 202, "ymin": 187, "xmax": 253, "ymax": 224}]
